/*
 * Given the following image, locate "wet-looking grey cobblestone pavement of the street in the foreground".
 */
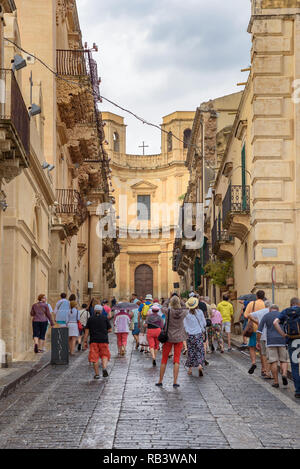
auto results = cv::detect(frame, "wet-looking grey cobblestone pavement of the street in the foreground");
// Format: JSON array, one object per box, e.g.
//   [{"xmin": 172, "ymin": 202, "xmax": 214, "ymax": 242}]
[{"xmin": 0, "ymin": 337, "xmax": 300, "ymax": 449}]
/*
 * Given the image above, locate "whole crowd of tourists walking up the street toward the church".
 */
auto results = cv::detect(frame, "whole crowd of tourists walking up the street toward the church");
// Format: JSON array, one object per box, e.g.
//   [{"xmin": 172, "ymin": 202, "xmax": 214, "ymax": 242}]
[{"xmin": 31, "ymin": 291, "xmax": 300, "ymax": 398}]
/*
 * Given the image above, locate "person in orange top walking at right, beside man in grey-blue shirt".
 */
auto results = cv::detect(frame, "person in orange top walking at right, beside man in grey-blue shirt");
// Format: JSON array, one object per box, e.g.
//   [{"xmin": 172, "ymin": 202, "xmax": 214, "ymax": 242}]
[{"xmin": 244, "ymin": 290, "xmax": 266, "ymax": 375}]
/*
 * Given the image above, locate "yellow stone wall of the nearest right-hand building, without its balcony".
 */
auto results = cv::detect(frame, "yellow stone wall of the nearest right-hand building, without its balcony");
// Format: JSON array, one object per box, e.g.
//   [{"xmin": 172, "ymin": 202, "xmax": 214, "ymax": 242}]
[{"xmin": 207, "ymin": 1, "xmax": 300, "ymax": 308}]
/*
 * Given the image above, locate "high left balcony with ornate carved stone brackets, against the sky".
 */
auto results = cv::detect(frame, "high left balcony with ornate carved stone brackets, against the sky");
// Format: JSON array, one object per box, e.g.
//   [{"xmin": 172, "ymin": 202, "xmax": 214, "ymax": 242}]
[{"xmin": 56, "ymin": 50, "xmax": 105, "ymax": 165}]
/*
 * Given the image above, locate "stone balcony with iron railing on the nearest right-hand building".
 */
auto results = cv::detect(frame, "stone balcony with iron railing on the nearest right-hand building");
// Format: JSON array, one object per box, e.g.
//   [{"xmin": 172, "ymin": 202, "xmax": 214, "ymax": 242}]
[{"xmin": 222, "ymin": 185, "xmax": 250, "ymax": 242}]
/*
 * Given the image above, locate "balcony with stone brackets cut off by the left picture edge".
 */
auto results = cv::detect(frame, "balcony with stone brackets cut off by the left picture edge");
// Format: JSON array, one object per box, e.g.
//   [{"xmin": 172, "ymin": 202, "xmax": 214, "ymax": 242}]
[{"xmin": 0, "ymin": 69, "xmax": 30, "ymax": 183}]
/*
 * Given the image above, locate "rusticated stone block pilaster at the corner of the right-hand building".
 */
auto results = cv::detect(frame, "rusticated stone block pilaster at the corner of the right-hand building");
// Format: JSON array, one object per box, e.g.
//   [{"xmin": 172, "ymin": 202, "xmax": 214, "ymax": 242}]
[{"xmin": 251, "ymin": 11, "xmax": 300, "ymax": 305}]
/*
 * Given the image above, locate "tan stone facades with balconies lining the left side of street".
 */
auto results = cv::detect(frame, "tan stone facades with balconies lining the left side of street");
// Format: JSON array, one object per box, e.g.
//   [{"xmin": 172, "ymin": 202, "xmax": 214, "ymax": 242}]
[{"xmin": 0, "ymin": 0, "xmax": 118, "ymax": 360}]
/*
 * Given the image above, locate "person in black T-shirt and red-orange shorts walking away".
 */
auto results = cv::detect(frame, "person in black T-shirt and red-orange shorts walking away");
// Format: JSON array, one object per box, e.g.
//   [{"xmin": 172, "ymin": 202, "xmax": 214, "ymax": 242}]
[{"xmin": 84, "ymin": 305, "xmax": 112, "ymax": 379}]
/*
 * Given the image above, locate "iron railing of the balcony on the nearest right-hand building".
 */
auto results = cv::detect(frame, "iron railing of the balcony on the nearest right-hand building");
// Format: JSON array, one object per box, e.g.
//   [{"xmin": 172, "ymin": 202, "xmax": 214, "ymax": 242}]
[{"xmin": 223, "ymin": 185, "xmax": 250, "ymax": 223}]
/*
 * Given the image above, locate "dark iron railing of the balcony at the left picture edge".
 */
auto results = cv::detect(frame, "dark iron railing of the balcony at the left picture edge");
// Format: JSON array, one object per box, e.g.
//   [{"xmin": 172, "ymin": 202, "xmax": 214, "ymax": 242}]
[{"xmin": 0, "ymin": 69, "xmax": 30, "ymax": 158}]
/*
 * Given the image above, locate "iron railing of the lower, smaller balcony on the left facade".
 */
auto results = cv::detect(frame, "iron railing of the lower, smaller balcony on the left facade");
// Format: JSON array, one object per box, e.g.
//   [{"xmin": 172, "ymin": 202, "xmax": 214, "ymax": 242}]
[{"xmin": 56, "ymin": 189, "xmax": 87, "ymax": 222}]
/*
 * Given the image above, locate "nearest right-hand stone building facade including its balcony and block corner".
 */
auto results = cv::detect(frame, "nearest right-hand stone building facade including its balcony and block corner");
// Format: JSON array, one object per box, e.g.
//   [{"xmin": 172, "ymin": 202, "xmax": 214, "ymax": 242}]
[{"xmin": 173, "ymin": 0, "xmax": 300, "ymax": 314}]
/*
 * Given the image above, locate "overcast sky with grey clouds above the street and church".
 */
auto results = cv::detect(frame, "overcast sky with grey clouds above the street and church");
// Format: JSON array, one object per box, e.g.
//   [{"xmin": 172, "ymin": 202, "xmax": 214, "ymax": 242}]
[{"xmin": 77, "ymin": 0, "xmax": 251, "ymax": 154}]
